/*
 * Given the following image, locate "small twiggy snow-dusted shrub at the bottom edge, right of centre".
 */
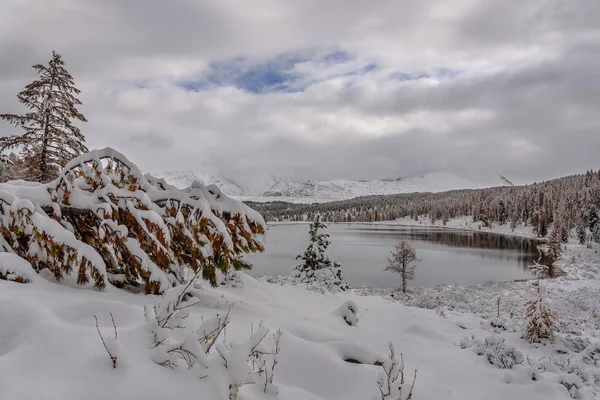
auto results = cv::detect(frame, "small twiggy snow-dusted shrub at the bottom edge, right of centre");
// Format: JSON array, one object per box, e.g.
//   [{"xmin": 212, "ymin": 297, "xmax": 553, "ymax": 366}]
[{"xmin": 373, "ymin": 343, "xmax": 417, "ymax": 400}]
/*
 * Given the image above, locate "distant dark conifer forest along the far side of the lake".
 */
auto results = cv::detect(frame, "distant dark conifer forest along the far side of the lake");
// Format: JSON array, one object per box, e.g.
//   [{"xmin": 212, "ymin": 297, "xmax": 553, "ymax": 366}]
[{"xmin": 248, "ymin": 171, "xmax": 600, "ymax": 243}]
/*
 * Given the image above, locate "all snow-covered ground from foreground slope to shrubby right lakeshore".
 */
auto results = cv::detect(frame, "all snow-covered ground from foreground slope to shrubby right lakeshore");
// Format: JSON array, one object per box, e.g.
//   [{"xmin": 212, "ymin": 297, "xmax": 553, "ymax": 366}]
[{"xmin": 0, "ymin": 217, "xmax": 600, "ymax": 400}]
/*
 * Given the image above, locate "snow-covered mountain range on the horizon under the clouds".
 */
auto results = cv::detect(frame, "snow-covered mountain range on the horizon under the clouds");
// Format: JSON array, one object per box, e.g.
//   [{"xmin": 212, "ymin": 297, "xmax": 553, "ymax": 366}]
[{"xmin": 153, "ymin": 171, "xmax": 496, "ymax": 203}]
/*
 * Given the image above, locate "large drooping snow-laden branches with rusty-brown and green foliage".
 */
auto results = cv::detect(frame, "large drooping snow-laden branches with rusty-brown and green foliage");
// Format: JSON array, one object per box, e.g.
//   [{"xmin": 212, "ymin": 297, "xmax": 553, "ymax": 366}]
[{"xmin": 0, "ymin": 148, "xmax": 265, "ymax": 294}]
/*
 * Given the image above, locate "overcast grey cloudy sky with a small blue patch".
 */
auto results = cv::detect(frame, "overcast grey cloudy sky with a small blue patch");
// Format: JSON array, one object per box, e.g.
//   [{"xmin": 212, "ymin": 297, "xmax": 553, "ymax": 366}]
[{"xmin": 0, "ymin": 0, "xmax": 600, "ymax": 182}]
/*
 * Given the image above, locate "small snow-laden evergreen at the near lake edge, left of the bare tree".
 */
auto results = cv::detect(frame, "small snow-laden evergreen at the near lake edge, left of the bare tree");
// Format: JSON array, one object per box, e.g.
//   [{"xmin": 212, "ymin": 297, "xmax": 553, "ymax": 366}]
[{"xmin": 292, "ymin": 214, "xmax": 350, "ymax": 292}]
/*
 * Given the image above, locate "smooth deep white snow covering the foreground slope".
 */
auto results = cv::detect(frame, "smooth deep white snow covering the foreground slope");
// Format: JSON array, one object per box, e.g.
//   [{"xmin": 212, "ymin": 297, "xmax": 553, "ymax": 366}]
[{"xmin": 0, "ymin": 255, "xmax": 598, "ymax": 400}]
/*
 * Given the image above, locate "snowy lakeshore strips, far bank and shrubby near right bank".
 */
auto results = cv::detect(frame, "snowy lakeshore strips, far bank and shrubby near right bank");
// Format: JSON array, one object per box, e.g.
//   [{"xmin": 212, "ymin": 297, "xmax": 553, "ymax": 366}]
[{"xmin": 258, "ymin": 218, "xmax": 600, "ymax": 338}]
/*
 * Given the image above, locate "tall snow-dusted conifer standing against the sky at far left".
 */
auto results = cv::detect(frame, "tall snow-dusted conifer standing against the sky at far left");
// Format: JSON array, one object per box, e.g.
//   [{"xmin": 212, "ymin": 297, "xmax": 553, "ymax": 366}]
[{"xmin": 0, "ymin": 51, "xmax": 88, "ymax": 182}]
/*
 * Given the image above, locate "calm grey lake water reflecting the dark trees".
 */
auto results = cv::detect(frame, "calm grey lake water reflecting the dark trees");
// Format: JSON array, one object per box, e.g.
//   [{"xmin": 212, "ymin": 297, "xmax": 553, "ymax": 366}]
[{"xmin": 245, "ymin": 224, "xmax": 538, "ymax": 287}]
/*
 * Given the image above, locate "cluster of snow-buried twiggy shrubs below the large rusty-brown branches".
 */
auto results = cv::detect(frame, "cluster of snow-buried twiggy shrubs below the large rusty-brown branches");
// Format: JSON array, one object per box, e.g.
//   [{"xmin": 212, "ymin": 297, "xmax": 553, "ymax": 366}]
[{"xmin": 145, "ymin": 279, "xmax": 282, "ymax": 399}]
